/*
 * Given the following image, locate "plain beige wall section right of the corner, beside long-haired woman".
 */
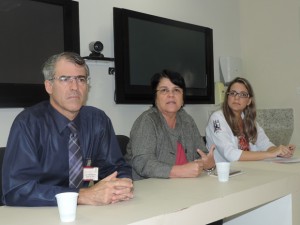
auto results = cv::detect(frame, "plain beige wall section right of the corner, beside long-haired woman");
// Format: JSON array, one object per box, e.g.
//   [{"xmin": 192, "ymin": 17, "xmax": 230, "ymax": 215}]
[{"xmin": 240, "ymin": 0, "xmax": 300, "ymax": 146}]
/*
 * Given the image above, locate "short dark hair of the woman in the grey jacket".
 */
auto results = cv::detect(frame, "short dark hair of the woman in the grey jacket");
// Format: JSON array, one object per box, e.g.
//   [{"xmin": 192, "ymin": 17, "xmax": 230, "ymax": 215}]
[{"xmin": 151, "ymin": 69, "xmax": 186, "ymax": 106}]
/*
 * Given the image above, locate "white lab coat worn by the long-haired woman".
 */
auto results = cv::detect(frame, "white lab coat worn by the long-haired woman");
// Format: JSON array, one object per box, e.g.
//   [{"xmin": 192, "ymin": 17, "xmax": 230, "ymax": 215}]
[{"xmin": 206, "ymin": 110, "xmax": 274, "ymax": 162}]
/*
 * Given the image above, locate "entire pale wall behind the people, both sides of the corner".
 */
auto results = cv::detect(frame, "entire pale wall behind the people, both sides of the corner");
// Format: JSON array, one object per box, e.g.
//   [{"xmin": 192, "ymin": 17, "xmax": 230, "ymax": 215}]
[{"xmin": 0, "ymin": 0, "xmax": 300, "ymax": 146}]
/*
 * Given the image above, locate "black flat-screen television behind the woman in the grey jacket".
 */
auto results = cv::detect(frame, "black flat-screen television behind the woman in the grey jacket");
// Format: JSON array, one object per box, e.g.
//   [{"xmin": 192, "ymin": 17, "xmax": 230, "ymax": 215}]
[{"xmin": 113, "ymin": 8, "xmax": 214, "ymax": 104}]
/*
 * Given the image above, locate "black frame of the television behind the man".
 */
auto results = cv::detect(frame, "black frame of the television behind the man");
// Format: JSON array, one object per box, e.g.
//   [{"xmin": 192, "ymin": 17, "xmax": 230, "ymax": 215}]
[{"xmin": 0, "ymin": 0, "xmax": 80, "ymax": 108}]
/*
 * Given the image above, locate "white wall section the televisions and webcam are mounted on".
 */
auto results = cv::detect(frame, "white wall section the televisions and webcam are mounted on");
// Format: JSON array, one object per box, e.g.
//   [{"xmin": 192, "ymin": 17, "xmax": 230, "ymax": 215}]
[{"xmin": 0, "ymin": 0, "xmax": 241, "ymax": 146}]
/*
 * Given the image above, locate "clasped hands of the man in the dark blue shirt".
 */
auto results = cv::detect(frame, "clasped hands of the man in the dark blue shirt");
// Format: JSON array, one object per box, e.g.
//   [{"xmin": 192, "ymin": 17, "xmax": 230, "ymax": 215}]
[{"xmin": 78, "ymin": 172, "xmax": 133, "ymax": 205}]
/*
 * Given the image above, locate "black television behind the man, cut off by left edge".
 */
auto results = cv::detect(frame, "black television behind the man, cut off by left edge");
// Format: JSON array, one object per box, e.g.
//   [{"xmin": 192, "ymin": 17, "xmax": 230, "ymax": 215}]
[{"xmin": 0, "ymin": 0, "xmax": 80, "ymax": 108}]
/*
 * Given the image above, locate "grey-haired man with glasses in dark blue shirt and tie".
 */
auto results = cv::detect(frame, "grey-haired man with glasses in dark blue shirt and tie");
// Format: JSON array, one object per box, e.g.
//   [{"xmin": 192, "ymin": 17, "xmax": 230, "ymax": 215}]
[{"xmin": 3, "ymin": 52, "xmax": 133, "ymax": 206}]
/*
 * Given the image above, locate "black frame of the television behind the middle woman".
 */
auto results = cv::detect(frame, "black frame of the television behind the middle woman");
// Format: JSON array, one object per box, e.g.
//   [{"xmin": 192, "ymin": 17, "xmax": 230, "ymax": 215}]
[{"xmin": 113, "ymin": 7, "xmax": 215, "ymax": 104}]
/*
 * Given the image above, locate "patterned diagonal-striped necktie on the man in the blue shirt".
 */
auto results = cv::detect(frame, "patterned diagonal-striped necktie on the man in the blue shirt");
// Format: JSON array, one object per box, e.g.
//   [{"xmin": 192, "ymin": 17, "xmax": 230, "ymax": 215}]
[{"xmin": 68, "ymin": 122, "xmax": 83, "ymax": 188}]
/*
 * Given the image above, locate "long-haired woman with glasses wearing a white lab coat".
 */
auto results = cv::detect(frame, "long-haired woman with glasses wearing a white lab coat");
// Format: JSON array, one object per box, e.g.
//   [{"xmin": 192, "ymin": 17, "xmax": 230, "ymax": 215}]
[{"xmin": 206, "ymin": 77, "xmax": 295, "ymax": 162}]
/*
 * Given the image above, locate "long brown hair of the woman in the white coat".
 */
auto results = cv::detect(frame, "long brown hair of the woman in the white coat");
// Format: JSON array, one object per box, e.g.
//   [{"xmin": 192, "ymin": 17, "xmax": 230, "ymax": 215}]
[{"xmin": 222, "ymin": 77, "xmax": 257, "ymax": 144}]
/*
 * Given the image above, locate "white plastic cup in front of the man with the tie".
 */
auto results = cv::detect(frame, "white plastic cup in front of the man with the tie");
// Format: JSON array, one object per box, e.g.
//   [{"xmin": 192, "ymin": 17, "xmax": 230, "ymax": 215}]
[{"xmin": 55, "ymin": 192, "xmax": 78, "ymax": 222}]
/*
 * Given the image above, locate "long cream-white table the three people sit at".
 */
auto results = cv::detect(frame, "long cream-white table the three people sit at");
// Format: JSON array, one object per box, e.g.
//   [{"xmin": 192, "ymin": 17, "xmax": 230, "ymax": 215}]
[{"xmin": 0, "ymin": 155, "xmax": 300, "ymax": 225}]
